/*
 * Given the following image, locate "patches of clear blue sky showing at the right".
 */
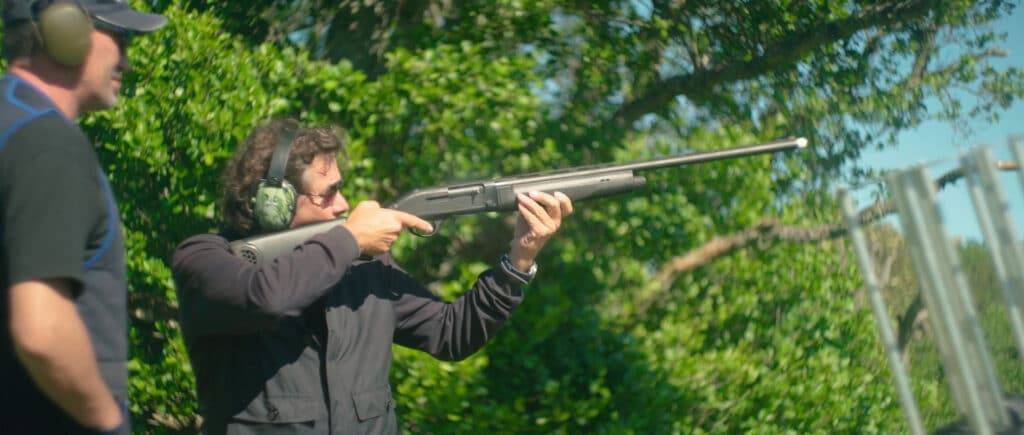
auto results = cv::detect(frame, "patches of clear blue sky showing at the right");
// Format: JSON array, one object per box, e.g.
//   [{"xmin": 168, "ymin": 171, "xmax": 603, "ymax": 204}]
[{"xmin": 857, "ymin": 5, "xmax": 1024, "ymax": 240}]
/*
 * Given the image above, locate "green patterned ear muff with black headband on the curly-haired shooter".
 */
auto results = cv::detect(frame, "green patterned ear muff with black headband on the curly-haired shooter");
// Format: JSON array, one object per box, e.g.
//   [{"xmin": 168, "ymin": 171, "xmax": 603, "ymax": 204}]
[{"xmin": 253, "ymin": 127, "xmax": 298, "ymax": 231}]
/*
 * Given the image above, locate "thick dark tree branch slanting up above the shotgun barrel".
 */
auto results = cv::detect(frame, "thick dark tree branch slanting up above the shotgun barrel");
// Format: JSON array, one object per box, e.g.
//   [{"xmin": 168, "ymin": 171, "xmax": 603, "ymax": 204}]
[{"xmin": 608, "ymin": 0, "xmax": 936, "ymax": 126}]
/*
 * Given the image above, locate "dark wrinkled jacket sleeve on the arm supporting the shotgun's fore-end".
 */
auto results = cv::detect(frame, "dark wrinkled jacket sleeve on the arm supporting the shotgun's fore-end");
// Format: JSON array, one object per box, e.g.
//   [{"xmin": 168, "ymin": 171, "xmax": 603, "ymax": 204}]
[{"xmin": 387, "ymin": 255, "xmax": 526, "ymax": 361}]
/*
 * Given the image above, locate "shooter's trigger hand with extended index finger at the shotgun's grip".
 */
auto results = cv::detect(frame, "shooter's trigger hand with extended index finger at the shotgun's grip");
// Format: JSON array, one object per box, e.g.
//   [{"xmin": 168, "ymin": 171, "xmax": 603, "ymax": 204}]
[{"xmin": 343, "ymin": 201, "xmax": 433, "ymax": 256}]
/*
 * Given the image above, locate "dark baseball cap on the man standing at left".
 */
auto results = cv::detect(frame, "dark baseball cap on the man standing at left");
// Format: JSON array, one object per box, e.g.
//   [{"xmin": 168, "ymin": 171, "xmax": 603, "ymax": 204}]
[{"xmin": 3, "ymin": 0, "xmax": 167, "ymax": 33}]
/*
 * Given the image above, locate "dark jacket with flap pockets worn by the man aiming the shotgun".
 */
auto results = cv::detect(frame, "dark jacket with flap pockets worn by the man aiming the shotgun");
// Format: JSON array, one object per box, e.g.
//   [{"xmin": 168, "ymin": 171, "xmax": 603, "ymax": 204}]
[{"xmin": 172, "ymin": 226, "xmax": 525, "ymax": 434}]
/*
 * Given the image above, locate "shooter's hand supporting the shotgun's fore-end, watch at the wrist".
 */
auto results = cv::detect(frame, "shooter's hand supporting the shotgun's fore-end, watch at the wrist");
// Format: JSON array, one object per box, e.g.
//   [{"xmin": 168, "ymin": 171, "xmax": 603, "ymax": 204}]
[{"xmin": 509, "ymin": 191, "xmax": 572, "ymax": 271}]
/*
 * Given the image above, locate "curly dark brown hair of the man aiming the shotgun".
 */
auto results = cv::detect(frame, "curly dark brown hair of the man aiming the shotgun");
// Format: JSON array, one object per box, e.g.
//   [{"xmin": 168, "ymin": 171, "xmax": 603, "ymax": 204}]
[{"xmin": 220, "ymin": 119, "xmax": 345, "ymax": 237}]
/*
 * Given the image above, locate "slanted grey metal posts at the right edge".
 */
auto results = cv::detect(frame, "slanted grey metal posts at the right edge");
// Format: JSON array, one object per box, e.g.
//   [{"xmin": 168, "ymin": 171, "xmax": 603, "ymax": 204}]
[{"xmin": 840, "ymin": 141, "xmax": 1024, "ymax": 435}]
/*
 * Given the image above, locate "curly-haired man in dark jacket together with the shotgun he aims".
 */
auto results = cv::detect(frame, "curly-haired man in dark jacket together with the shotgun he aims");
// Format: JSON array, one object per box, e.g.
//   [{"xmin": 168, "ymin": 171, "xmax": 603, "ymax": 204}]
[{"xmin": 172, "ymin": 122, "xmax": 806, "ymax": 434}]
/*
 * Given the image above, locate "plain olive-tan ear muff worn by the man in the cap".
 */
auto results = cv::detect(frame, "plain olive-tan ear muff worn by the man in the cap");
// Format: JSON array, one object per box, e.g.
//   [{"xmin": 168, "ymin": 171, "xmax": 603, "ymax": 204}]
[{"xmin": 36, "ymin": 2, "xmax": 92, "ymax": 67}]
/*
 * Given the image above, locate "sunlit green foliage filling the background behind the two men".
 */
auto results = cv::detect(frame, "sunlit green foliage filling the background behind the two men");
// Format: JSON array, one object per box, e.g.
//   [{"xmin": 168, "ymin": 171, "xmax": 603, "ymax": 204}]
[{"xmin": 24, "ymin": 0, "xmax": 1024, "ymax": 433}]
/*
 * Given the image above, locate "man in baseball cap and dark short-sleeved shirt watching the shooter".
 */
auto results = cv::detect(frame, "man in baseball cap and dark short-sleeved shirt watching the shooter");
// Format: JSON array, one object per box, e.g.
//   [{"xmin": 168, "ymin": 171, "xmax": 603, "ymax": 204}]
[{"xmin": 0, "ymin": 0, "xmax": 167, "ymax": 434}]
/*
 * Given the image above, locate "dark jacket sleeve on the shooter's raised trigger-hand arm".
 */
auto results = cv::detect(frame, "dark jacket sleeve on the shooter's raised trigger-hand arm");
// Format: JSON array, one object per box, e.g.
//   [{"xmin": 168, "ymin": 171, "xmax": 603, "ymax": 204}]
[{"xmin": 171, "ymin": 226, "xmax": 359, "ymax": 337}]
